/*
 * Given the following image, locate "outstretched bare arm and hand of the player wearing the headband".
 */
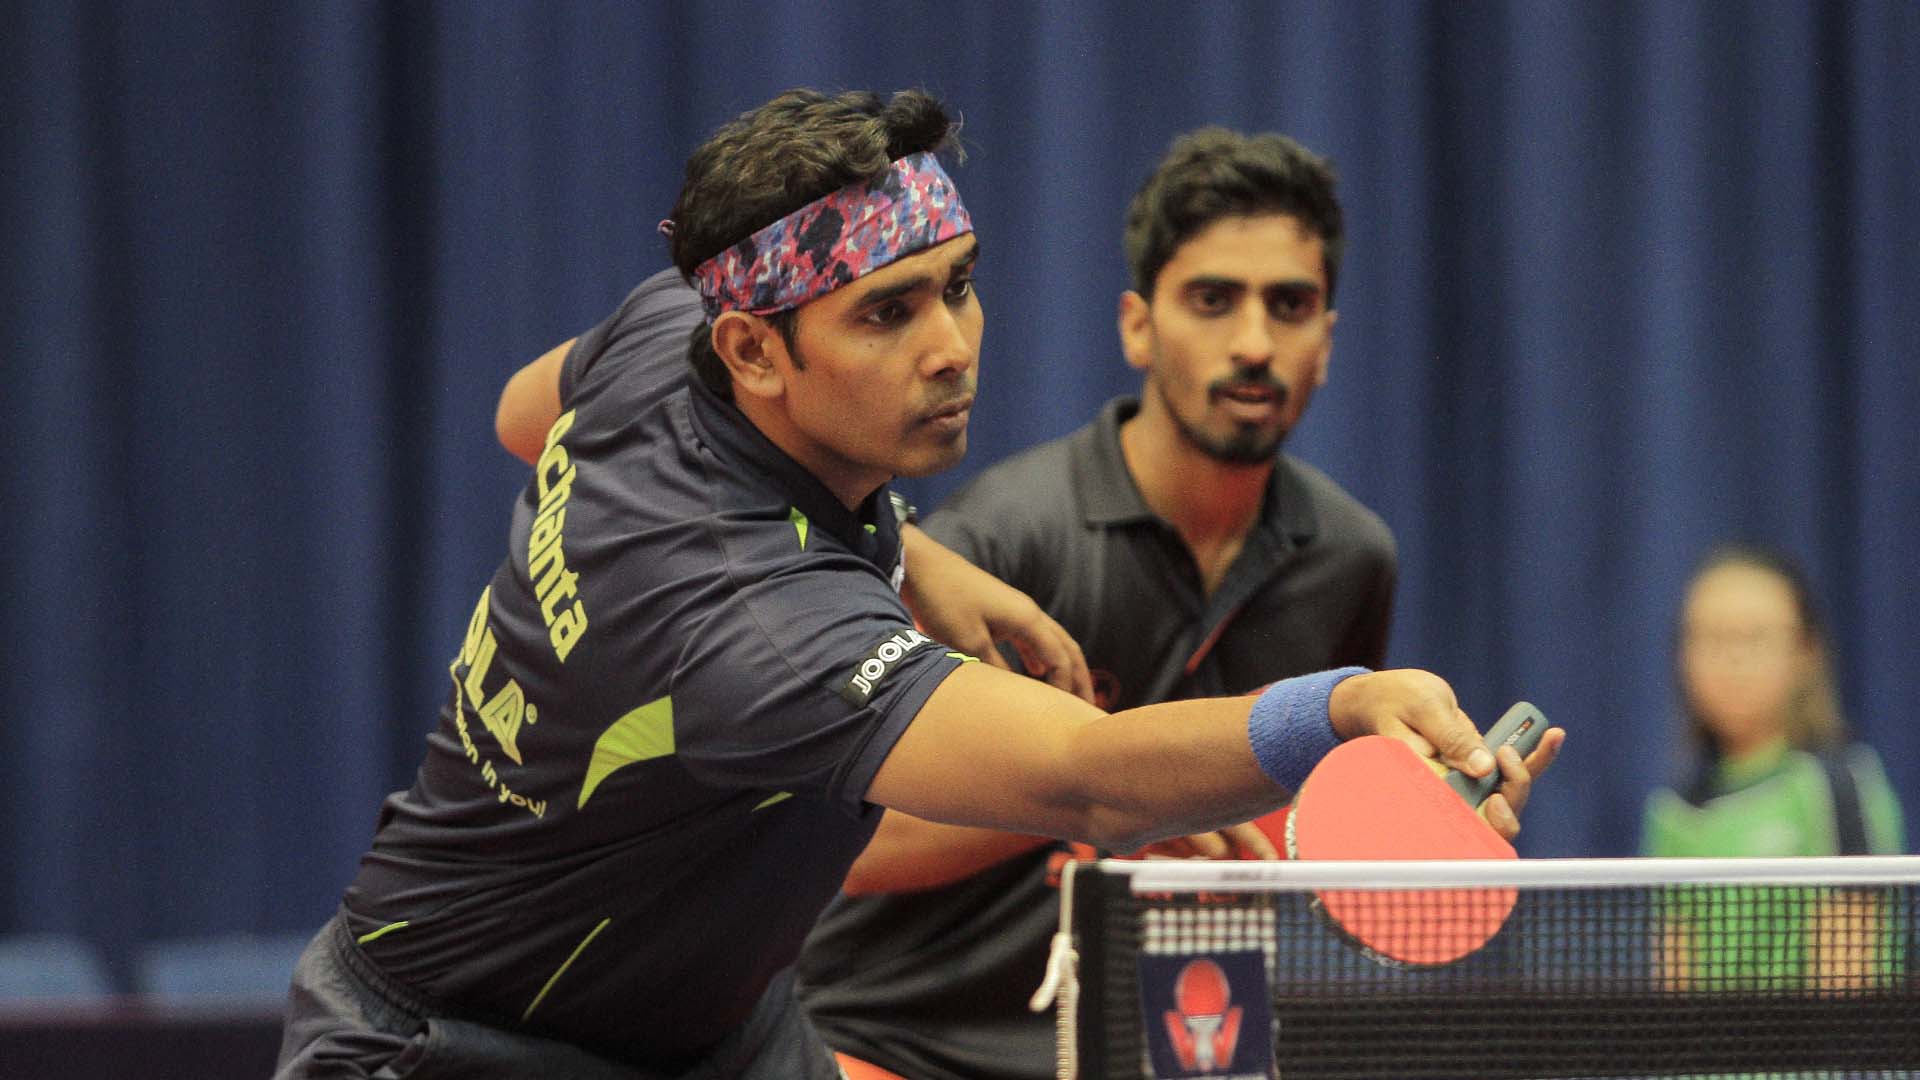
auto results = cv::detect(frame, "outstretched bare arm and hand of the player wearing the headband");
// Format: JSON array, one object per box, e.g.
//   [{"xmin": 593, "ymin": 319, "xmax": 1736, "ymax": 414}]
[{"xmin": 868, "ymin": 665, "xmax": 1528, "ymax": 851}]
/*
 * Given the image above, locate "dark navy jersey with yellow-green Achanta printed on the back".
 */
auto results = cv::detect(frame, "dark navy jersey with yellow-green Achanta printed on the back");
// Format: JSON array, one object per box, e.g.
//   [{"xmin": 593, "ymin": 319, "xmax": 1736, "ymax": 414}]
[{"xmin": 346, "ymin": 275, "xmax": 964, "ymax": 1070}]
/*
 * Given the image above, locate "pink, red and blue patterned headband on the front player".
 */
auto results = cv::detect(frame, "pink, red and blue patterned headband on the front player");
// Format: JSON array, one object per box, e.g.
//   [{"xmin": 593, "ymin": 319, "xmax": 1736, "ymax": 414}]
[{"xmin": 693, "ymin": 152, "xmax": 973, "ymax": 321}]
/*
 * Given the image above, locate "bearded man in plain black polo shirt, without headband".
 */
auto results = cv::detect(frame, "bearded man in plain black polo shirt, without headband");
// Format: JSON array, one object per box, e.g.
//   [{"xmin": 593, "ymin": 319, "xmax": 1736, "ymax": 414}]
[{"xmin": 801, "ymin": 129, "xmax": 1561, "ymax": 1080}]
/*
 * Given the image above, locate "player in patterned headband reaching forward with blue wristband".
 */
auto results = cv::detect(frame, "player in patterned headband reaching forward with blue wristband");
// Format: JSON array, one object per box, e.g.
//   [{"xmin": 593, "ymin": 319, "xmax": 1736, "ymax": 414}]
[{"xmin": 280, "ymin": 90, "xmax": 1528, "ymax": 1080}]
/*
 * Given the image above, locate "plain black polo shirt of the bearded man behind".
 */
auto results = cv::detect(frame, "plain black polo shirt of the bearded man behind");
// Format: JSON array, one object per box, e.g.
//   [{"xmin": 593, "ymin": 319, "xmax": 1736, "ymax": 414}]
[{"xmin": 801, "ymin": 398, "xmax": 1396, "ymax": 1080}]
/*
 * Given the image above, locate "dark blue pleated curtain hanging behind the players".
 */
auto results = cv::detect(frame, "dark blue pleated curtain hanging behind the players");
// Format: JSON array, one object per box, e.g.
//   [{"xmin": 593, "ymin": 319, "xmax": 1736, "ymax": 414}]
[{"xmin": 0, "ymin": 0, "xmax": 1920, "ymax": 983}]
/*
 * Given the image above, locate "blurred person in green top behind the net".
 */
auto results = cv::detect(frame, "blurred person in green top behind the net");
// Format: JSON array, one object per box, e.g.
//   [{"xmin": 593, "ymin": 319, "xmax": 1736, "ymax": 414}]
[{"xmin": 1642, "ymin": 546, "xmax": 1905, "ymax": 990}]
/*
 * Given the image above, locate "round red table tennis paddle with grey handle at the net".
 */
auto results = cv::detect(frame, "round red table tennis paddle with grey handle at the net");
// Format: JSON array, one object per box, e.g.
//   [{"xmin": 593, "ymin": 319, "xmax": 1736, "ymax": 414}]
[{"xmin": 1286, "ymin": 701, "xmax": 1548, "ymax": 967}]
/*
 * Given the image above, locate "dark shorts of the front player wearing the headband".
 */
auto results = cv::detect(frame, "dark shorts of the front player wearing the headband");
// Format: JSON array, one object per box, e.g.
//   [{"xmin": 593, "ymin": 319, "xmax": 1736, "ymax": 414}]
[{"xmin": 275, "ymin": 915, "xmax": 841, "ymax": 1080}]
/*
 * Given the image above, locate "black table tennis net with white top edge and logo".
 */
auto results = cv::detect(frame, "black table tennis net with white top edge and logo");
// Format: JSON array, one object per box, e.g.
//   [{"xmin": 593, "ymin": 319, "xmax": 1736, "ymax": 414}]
[{"xmin": 1056, "ymin": 859, "xmax": 1920, "ymax": 1080}]
